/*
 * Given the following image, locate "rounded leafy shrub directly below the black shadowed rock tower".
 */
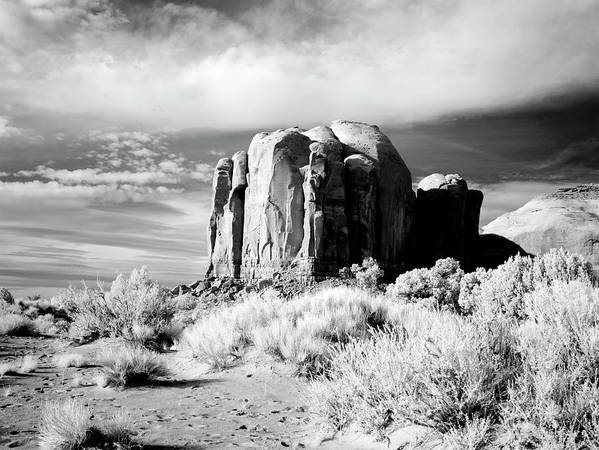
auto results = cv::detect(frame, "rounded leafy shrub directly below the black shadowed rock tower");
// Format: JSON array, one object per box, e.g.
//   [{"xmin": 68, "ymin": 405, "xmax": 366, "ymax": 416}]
[{"xmin": 387, "ymin": 258, "xmax": 464, "ymax": 310}]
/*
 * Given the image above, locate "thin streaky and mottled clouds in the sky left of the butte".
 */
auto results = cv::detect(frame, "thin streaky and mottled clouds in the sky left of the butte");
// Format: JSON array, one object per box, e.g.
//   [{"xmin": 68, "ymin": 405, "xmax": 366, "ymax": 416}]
[{"xmin": 0, "ymin": 126, "xmax": 212, "ymax": 293}]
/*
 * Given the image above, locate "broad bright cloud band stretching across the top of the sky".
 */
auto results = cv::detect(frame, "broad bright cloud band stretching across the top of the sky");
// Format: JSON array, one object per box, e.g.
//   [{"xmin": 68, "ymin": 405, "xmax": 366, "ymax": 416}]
[{"xmin": 0, "ymin": 0, "xmax": 599, "ymax": 128}]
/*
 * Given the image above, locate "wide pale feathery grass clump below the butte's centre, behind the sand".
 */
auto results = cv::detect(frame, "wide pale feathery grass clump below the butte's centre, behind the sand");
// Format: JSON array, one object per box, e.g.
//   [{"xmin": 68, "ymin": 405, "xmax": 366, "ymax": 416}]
[{"xmin": 181, "ymin": 287, "xmax": 392, "ymax": 375}]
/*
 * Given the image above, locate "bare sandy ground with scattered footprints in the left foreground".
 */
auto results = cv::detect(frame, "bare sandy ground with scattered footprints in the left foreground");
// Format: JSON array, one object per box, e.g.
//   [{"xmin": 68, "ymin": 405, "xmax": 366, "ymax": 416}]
[{"xmin": 0, "ymin": 337, "xmax": 424, "ymax": 449}]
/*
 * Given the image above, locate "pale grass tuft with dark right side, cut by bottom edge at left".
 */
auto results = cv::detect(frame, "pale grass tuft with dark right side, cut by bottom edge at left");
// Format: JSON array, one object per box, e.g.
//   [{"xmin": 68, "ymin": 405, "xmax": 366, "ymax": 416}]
[{"xmin": 39, "ymin": 399, "xmax": 133, "ymax": 450}]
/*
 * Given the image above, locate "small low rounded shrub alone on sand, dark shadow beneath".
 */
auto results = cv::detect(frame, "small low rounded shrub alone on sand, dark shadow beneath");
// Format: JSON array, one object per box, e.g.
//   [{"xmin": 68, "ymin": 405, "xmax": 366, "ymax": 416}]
[{"xmin": 97, "ymin": 346, "xmax": 169, "ymax": 387}]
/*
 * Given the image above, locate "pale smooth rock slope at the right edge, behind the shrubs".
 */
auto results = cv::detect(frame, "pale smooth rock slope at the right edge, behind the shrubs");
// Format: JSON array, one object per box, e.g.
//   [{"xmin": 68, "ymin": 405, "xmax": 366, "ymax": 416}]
[{"xmin": 484, "ymin": 185, "xmax": 599, "ymax": 265}]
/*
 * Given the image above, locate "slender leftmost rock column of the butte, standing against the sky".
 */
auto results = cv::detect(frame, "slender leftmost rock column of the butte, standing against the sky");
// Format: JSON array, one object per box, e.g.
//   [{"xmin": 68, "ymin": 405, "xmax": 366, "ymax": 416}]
[{"xmin": 207, "ymin": 158, "xmax": 233, "ymax": 275}]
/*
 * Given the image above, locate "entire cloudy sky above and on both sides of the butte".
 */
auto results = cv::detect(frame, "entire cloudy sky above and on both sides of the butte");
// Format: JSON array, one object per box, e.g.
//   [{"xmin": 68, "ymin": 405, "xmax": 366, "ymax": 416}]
[{"xmin": 0, "ymin": 0, "xmax": 599, "ymax": 295}]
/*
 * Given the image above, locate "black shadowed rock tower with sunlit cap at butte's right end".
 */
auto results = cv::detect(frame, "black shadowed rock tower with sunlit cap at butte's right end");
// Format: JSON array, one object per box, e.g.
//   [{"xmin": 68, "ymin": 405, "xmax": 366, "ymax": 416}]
[{"xmin": 413, "ymin": 173, "xmax": 483, "ymax": 270}]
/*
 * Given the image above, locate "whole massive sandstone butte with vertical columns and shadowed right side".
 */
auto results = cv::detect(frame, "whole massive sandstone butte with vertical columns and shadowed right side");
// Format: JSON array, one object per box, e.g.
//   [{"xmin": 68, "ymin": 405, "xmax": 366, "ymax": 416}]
[{"xmin": 208, "ymin": 121, "xmax": 516, "ymax": 279}]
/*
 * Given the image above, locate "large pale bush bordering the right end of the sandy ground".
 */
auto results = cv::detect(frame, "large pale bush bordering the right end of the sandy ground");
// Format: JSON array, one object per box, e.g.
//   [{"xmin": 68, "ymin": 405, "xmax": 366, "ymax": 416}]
[{"xmin": 312, "ymin": 306, "xmax": 520, "ymax": 439}]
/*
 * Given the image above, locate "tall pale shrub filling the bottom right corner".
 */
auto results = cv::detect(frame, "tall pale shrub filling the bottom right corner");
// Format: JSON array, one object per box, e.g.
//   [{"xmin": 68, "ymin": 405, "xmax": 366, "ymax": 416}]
[{"xmin": 504, "ymin": 281, "xmax": 599, "ymax": 448}]
